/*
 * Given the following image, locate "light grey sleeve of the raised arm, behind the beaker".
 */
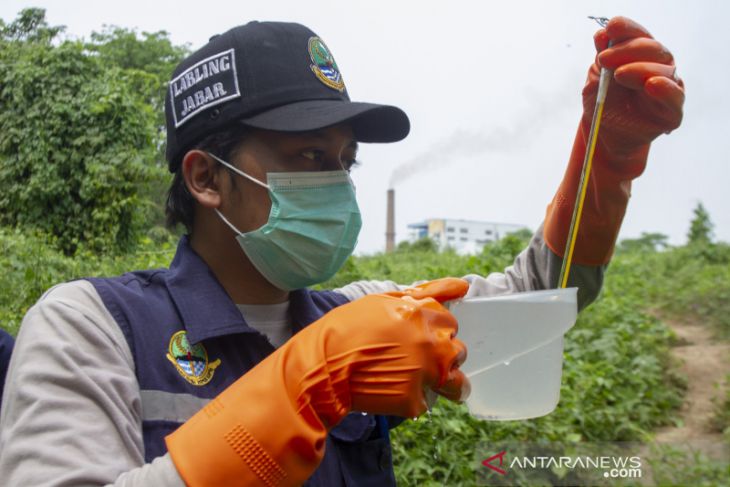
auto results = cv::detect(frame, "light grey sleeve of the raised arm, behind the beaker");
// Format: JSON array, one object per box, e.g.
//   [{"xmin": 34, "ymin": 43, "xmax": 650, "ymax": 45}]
[{"xmin": 335, "ymin": 226, "xmax": 605, "ymax": 309}]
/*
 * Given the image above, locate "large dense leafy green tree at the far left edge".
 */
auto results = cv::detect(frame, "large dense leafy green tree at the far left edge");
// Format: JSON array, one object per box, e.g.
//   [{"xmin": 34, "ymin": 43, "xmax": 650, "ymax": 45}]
[{"xmin": 0, "ymin": 9, "xmax": 158, "ymax": 254}]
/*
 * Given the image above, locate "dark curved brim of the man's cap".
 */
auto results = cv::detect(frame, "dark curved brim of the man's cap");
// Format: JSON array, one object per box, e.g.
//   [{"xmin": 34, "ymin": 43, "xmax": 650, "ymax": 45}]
[{"xmin": 241, "ymin": 100, "xmax": 411, "ymax": 142}]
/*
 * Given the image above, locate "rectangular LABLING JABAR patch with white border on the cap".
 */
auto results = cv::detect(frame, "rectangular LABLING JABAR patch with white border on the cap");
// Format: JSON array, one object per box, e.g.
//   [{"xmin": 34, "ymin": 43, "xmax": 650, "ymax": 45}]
[{"xmin": 170, "ymin": 49, "xmax": 241, "ymax": 128}]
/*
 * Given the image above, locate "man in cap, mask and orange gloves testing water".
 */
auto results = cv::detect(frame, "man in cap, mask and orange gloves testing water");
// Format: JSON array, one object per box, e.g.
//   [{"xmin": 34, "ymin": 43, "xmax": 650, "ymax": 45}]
[{"xmin": 0, "ymin": 18, "xmax": 684, "ymax": 486}]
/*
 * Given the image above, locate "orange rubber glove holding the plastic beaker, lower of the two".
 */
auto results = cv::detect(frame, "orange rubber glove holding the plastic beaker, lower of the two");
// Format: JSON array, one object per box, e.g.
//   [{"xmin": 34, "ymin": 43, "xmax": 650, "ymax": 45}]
[{"xmin": 166, "ymin": 279, "xmax": 469, "ymax": 487}]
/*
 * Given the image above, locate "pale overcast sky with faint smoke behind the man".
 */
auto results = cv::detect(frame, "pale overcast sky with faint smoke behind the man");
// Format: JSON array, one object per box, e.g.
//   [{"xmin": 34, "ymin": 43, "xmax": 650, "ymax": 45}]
[{"xmin": 0, "ymin": 0, "xmax": 730, "ymax": 253}]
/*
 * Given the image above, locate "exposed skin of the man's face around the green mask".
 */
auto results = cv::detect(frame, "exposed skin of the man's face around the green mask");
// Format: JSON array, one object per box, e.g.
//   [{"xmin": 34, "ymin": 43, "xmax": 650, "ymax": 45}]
[{"xmin": 219, "ymin": 124, "xmax": 357, "ymax": 233}]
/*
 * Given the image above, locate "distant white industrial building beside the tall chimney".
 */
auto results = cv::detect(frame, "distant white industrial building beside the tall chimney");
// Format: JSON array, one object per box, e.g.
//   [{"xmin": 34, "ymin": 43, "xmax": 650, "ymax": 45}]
[{"xmin": 408, "ymin": 218, "xmax": 527, "ymax": 254}]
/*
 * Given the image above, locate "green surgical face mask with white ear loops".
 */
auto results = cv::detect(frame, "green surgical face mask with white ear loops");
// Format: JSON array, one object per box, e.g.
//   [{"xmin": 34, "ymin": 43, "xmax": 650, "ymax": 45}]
[{"xmin": 210, "ymin": 154, "xmax": 362, "ymax": 291}]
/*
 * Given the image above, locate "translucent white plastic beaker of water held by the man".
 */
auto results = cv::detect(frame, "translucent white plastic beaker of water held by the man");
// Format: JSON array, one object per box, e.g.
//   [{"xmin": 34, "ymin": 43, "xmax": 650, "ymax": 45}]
[{"xmin": 449, "ymin": 288, "xmax": 578, "ymax": 420}]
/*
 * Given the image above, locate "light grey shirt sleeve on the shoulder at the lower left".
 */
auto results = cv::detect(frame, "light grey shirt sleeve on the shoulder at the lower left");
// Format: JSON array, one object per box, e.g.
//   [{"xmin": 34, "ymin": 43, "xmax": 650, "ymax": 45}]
[{"xmin": 0, "ymin": 281, "xmax": 184, "ymax": 487}]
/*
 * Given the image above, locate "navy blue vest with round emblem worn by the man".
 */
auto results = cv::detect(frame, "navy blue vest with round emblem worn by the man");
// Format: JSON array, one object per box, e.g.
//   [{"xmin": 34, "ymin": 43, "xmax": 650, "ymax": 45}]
[{"xmin": 89, "ymin": 237, "xmax": 395, "ymax": 487}]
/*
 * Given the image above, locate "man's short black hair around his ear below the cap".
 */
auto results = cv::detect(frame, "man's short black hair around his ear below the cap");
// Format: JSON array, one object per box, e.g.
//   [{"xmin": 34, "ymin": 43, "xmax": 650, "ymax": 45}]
[{"xmin": 165, "ymin": 125, "xmax": 247, "ymax": 234}]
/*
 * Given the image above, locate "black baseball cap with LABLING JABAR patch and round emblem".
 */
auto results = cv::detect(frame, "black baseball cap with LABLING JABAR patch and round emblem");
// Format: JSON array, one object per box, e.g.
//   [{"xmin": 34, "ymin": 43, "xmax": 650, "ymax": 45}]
[{"xmin": 165, "ymin": 22, "xmax": 410, "ymax": 171}]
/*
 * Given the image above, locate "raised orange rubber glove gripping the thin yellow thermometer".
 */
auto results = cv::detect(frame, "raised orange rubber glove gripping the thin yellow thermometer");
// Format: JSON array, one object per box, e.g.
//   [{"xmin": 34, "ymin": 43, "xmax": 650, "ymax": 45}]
[{"xmin": 544, "ymin": 17, "xmax": 684, "ymax": 265}]
